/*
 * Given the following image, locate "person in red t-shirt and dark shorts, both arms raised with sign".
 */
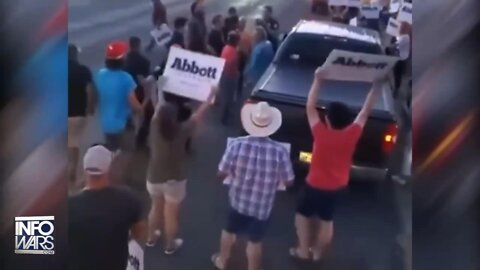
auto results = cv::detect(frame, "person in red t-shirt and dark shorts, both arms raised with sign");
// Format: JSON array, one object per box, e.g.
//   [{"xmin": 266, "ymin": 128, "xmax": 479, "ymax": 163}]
[{"xmin": 290, "ymin": 68, "xmax": 381, "ymax": 261}]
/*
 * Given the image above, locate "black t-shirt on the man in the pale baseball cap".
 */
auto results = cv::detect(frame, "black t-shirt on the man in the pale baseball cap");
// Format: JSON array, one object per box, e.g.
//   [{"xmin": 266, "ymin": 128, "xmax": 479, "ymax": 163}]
[{"xmin": 68, "ymin": 187, "xmax": 142, "ymax": 270}]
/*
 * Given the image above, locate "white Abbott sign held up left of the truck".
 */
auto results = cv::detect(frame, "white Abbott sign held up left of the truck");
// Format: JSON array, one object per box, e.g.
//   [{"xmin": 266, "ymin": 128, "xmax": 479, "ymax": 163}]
[{"xmin": 162, "ymin": 47, "xmax": 225, "ymax": 101}]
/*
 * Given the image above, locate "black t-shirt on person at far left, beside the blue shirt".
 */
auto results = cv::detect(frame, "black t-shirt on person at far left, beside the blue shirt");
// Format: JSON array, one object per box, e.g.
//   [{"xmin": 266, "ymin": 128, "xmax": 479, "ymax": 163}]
[{"xmin": 68, "ymin": 61, "xmax": 92, "ymax": 117}]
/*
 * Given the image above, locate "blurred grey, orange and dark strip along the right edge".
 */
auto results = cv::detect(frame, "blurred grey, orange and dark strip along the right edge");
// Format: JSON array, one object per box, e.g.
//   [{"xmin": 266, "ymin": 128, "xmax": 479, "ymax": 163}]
[{"xmin": 413, "ymin": 0, "xmax": 480, "ymax": 270}]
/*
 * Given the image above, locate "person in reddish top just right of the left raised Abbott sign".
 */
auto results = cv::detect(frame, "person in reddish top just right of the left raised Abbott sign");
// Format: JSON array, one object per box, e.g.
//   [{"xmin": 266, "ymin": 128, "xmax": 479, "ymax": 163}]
[{"xmin": 220, "ymin": 31, "xmax": 240, "ymax": 125}]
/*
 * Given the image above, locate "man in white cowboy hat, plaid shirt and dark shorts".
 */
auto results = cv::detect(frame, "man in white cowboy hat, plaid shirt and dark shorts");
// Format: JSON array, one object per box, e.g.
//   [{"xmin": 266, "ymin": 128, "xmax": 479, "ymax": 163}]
[{"xmin": 211, "ymin": 102, "xmax": 294, "ymax": 270}]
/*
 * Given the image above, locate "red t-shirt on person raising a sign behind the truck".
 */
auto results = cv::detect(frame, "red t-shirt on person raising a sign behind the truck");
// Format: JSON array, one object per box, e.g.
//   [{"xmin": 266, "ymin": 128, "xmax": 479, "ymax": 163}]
[{"xmin": 307, "ymin": 121, "xmax": 362, "ymax": 190}]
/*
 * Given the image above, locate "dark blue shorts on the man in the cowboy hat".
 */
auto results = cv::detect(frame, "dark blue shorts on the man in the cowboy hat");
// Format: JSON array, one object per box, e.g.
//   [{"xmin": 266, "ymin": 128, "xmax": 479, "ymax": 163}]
[{"xmin": 225, "ymin": 208, "xmax": 269, "ymax": 243}]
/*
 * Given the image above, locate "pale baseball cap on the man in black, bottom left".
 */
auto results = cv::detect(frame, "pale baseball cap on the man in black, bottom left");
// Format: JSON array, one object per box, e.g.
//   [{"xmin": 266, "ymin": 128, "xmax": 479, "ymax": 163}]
[{"xmin": 83, "ymin": 145, "xmax": 113, "ymax": 175}]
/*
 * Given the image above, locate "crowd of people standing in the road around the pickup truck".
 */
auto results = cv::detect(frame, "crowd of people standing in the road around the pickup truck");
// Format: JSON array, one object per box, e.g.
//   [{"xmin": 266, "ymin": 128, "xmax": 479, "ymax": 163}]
[{"xmin": 68, "ymin": 0, "xmax": 412, "ymax": 270}]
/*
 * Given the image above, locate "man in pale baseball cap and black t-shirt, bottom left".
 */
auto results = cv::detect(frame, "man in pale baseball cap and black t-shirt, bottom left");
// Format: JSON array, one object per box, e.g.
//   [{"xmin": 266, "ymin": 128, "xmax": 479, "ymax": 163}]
[{"xmin": 68, "ymin": 145, "xmax": 146, "ymax": 270}]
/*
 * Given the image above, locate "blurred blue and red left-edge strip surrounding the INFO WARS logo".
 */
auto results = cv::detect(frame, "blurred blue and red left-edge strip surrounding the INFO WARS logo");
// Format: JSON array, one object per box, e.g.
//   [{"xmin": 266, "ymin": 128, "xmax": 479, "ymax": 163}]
[{"xmin": 0, "ymin": 0, "xmax": 67, "ymax": 269}]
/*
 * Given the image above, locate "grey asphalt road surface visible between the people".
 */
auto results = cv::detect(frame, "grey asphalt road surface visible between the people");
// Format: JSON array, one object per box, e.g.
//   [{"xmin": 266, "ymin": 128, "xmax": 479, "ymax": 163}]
[{"xmin": 69, "ymin": 0, "xmax": 406, "ymax": 270}]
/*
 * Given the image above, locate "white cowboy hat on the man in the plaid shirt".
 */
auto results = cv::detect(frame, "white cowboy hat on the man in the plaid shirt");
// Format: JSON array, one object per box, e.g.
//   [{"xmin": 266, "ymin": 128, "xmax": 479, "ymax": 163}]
[{"xmin": 241, "ymin": 102, "xmax": 282, "ymax": 137}]
